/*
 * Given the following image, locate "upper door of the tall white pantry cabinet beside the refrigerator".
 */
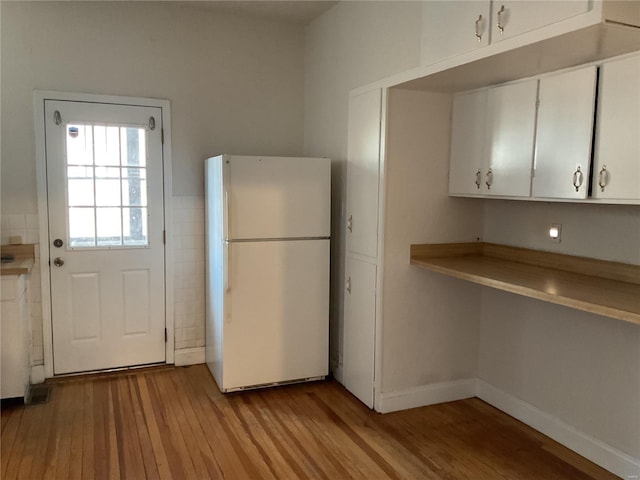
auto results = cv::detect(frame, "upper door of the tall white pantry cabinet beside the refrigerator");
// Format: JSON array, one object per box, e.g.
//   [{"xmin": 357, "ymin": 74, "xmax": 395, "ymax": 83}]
[{"xmin": 347, "ymin": 90, "xmax": 382, "ymax": 258}]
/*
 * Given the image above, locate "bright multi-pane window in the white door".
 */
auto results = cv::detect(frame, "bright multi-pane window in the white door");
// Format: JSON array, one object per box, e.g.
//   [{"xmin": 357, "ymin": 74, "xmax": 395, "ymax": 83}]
[{"xmin": 67, "ymin": 124, "xmax": 149, "ymax": 248}]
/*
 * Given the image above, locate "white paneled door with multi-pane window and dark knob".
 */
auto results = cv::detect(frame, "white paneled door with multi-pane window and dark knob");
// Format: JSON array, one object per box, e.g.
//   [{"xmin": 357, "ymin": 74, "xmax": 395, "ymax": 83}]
[{"xmin": 45, "ymin": 100, "xmax": 165, "ymax": 375}]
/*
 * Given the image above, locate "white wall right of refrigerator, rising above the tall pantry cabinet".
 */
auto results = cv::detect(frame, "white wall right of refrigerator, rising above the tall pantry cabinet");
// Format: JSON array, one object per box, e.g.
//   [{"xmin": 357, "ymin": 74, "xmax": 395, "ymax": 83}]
[{"xmin": 304, "ymin": 1, "xmax": 422, "ymax": 365}]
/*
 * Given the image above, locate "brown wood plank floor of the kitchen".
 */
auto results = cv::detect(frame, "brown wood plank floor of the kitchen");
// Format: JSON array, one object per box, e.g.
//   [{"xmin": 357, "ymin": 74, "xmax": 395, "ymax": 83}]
[{"xmin": 0, "ymin": 365, "xmax": 617, "ymax": 480}]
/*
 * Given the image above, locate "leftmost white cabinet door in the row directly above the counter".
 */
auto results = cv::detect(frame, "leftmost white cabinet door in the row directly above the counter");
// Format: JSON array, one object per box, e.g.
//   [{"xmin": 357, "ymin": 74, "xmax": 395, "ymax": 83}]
[{"xmin": 449, "ymin": 90, "xmax": 487, "ymax": 195}]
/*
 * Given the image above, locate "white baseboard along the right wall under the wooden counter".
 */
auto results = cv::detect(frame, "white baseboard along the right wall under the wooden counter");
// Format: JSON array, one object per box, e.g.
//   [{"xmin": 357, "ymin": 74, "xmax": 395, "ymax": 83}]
[{"xmin": 476, "ymin": 379, "xmax": 640, "ymax": 480}]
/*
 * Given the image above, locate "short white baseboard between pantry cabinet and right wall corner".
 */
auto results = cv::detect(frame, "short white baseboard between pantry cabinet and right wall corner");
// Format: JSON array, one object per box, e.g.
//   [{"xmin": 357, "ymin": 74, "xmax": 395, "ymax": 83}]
[{"xmin": 376, "ymin": 378, "xmax": 476, "ymax": 413}]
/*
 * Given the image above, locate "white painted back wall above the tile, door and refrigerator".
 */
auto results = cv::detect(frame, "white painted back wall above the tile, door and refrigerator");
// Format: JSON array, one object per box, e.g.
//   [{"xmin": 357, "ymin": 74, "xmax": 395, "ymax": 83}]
[{"xmin": 0, "ymin": 1, "xmax": 304, "ymax": 213}]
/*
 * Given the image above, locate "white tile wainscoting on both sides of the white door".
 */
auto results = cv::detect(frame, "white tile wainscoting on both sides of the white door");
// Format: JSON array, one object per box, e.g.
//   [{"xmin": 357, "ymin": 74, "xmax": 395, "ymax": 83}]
[{"xmin": 0, "ymin": 196, "xmax": 205, "ymax": 365}]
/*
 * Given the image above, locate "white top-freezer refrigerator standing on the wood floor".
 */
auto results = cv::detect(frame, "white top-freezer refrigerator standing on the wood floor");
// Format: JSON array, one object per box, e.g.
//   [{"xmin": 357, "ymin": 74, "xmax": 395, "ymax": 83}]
[{"xmin": 205, "ymin": 155, "xmax": 331, "ymax": 392}]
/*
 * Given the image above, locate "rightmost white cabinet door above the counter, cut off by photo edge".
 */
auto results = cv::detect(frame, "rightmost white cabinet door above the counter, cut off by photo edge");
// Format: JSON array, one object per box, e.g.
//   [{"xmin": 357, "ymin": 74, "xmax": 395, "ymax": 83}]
[{"xmin": 593, "ymin": 56, "xmax": 640, "ymax": 200}]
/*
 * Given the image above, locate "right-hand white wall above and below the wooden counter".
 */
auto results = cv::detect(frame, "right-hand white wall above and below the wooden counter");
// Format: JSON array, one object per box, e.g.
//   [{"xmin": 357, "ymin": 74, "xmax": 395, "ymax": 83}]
[{"xmin": 478, "ymin": 197, "xmax": 640, "ymax": 459}]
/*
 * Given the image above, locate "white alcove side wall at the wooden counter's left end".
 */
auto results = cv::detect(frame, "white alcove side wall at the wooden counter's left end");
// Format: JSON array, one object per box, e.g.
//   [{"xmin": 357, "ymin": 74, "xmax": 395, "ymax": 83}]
[{"xmin": 382, "ymin": 89, "xmax": 482, "ymax": 395}]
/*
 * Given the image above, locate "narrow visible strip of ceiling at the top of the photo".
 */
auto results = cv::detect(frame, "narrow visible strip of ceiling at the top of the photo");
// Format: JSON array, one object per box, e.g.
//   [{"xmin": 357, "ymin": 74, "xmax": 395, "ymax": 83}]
[{"xmin": 181, "ymin": 0, "xmax": 338, "ymax": 25}]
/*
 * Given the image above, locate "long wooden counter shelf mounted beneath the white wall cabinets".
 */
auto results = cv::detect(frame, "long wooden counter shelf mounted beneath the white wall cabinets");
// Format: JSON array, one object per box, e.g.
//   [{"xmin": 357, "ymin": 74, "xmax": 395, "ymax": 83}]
[{"xmin": 410, "ymin": 243, "xmax": 640, "ymax": 325}]
